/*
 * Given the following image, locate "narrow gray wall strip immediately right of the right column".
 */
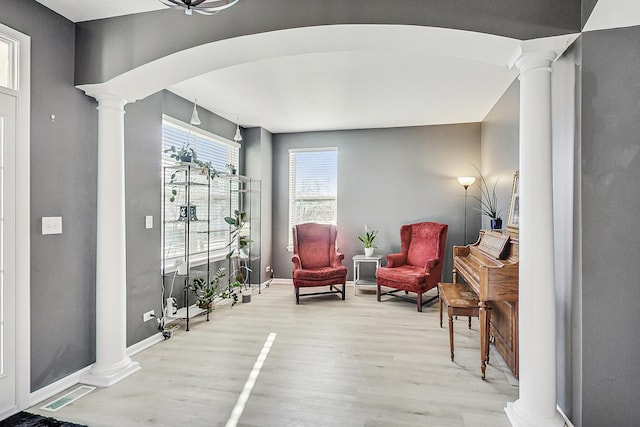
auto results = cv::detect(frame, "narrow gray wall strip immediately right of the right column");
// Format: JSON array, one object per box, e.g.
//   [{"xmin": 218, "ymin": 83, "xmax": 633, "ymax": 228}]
[{"xmin": 552, "ymin": 42, "xmax": 582, "ymax": 425}]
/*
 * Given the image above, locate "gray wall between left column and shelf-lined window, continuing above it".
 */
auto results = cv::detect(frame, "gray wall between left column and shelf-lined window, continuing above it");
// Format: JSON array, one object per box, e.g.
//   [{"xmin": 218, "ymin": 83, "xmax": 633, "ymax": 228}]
[{"xmin": 125, "ymin": 91, "xmax": 244, "ymax": 346}]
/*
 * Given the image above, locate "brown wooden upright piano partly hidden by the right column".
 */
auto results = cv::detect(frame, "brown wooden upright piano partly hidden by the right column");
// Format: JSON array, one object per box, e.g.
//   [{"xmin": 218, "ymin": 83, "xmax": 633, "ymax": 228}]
[{"xmin": 453, "ymin": 230, "xmax": 519, "ymax": 378}]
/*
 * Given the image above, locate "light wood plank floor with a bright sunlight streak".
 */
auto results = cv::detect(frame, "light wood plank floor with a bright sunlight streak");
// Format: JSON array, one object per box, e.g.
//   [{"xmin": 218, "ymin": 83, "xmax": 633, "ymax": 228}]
[{"xmin": 29, "ymin": 283, "xmax": 518, "ymax": 427}]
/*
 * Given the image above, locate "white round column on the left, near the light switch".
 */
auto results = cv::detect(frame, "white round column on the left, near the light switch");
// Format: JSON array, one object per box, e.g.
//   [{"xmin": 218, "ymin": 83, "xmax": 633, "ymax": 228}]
[{"xmin": 81, "ymin": 85, "xmax": 140, "ymax": 387}]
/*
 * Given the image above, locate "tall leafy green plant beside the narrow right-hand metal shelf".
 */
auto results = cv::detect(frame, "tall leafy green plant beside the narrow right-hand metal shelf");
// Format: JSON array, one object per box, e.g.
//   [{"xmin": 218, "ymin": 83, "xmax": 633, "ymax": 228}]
[{"xmin": 224, "ymin": 209, "xmax": 252, "ymax": 302}]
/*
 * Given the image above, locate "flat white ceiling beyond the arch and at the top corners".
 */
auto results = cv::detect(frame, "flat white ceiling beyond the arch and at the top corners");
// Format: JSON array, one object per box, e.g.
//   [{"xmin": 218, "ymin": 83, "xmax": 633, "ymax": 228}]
[{"xmin": 33, "ymin": 0, "xmax": 640, "ymax": 133}]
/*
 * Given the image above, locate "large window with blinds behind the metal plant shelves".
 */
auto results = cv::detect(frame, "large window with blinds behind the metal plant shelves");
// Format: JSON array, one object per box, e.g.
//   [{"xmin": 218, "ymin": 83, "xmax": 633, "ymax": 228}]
[{"xmin": 162, "ymin": 116, "xmax": 240, "ymax": 269}]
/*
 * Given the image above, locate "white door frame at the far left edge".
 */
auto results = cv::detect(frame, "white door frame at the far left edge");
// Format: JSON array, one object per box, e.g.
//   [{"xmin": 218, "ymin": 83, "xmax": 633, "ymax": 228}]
[{"xmin": 0, "ymin": 24, "xmax": 31, "ymax": 416}]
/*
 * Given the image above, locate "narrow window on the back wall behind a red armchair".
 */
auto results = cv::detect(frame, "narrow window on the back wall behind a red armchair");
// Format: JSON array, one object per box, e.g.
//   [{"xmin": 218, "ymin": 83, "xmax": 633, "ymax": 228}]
[{"xmin": 288, "ymin": 148, "xmax": 338, "ymax": 250}]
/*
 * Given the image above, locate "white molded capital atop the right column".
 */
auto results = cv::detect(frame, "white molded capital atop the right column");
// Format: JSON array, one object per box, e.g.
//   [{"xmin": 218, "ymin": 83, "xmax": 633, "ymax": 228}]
[{"xmin": 508, "ymin": 34, "xmax": 579, "ymax": 75}]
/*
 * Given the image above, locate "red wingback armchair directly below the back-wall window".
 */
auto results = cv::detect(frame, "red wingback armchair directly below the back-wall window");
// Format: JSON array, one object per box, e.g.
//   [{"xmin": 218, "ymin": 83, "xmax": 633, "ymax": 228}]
[{"xmin": 291, "ymin": 223, "xmax": 347, "ymax": 304}]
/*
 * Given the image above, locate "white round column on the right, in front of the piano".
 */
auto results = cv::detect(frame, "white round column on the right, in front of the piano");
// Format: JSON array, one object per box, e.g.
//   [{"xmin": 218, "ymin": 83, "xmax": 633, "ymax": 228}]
[{"xmin": 506, "ymin": 38, "xmax": 568, "ymax": 427}]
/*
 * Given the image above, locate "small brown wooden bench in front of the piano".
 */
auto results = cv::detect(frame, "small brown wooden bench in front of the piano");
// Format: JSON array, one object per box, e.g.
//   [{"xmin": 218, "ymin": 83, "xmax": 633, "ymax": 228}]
[{"xmin": 438, "ymin": 282, "xmax": 480, "ymax": 361}]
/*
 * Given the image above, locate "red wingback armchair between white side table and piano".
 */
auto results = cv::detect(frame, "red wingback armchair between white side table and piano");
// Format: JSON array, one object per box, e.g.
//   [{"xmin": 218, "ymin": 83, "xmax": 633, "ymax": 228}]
[{"xmin": 376, "ymin": 222, "xmax": 448, "ymax": 311}]
